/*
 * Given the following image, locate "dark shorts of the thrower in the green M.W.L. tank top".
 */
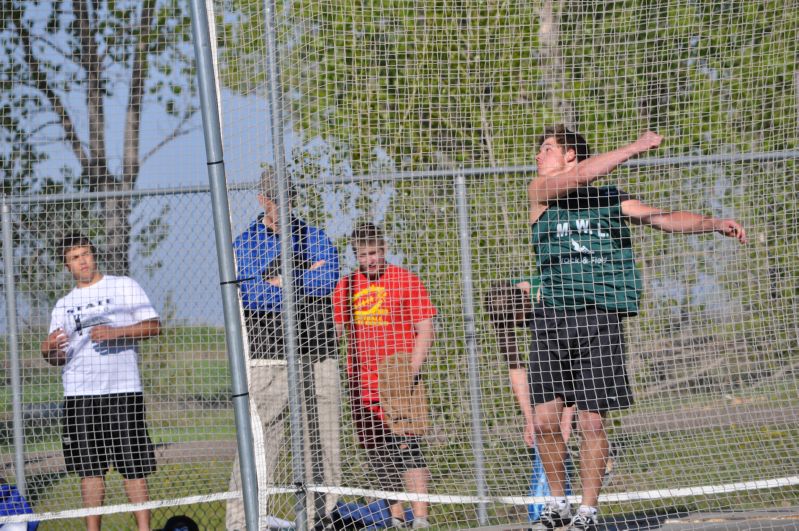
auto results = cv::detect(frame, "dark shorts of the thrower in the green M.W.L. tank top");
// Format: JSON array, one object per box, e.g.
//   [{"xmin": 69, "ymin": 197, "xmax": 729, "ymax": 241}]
[{"xmin": 529, "ymin": 306, "xmax": 633, "ymax": 413}]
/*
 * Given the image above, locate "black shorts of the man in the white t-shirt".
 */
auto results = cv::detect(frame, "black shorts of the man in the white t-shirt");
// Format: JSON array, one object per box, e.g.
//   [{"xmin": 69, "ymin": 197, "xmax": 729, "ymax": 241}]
[{"xmin": 61, "ymin": 393, "xmax": 155, "ymax": 479}]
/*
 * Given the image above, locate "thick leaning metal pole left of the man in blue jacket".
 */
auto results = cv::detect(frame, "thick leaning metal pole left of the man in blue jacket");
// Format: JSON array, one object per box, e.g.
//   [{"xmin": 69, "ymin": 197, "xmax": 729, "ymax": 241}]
[{"xmin": 186, "ymin": 0, "xmax": 258, "ymax": 531}]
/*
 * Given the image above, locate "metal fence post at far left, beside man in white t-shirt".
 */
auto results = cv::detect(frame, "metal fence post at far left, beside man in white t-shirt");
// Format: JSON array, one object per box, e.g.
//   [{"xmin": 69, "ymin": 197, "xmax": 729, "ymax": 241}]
[{"xmin": 2, "ymin": 200, "xmax": 27, "ymax": 496}]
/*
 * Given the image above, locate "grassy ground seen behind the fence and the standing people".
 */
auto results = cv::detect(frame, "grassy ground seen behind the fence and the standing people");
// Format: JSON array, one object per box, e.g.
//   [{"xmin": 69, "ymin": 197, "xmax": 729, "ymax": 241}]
[{"xmin": 0, "ymin": 327, "xmax": 799, "ymax": 531}]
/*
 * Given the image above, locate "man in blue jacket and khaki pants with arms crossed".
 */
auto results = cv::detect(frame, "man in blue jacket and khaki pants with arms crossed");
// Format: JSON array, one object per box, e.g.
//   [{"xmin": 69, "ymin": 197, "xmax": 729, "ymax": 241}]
[{"xmin": 226, "ymin": 171, "xmax": 341, "ymax": 530}]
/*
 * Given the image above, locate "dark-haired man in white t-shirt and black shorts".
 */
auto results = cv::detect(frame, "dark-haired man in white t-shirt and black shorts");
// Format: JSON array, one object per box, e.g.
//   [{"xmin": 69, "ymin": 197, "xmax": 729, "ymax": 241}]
[{"xmin": 41, "ymin": 234, "xmax": 161, "ymax": 531}]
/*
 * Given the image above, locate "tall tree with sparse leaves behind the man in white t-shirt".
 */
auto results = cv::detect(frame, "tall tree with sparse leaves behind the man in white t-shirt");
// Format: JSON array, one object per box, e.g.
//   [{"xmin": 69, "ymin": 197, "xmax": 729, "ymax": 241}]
[{"xmin": 0, "ymin": 0, "xmax": 196, "ymax": 274}]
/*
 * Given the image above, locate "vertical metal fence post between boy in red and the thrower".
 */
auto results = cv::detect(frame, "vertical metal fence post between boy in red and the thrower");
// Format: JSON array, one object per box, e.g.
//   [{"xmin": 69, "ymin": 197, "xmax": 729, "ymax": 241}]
[{"xmin": 455, "ymin": 174, "xmax": 488, "ymax": 526}]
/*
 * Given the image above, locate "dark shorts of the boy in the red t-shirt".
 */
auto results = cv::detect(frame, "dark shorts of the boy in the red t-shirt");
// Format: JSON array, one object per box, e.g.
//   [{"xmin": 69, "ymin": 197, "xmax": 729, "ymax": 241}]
[{"xmin": 366, "ymin": 435, "xmax": 427, "ymax": 490}]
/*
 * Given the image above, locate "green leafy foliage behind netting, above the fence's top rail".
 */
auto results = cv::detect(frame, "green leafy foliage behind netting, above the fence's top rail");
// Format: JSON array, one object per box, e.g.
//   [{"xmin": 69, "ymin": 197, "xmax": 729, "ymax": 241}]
[{"xmin": 223, "ymin": 0, "xmax": 799, "ymax": 166}]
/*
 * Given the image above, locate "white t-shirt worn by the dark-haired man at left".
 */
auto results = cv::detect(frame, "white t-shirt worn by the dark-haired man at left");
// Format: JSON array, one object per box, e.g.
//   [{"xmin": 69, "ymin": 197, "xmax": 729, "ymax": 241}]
[{"xmin": 50, "ymin": 275, "xmax": 158, "ymax": 396}]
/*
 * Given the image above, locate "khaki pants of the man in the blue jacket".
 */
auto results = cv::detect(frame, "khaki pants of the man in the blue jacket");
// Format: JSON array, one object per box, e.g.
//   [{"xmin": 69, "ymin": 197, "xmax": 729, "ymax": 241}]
[{"xmin": 225, "ymin": 358, "xmax": 341, "ymax": 531}]
